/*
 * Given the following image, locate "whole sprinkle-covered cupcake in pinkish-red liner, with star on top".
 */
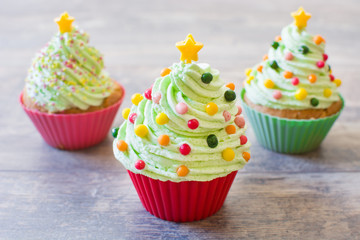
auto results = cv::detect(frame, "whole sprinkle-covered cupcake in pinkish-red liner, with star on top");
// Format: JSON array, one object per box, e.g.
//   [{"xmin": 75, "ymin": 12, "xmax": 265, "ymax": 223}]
[{"xmin": 20, "ymin": 12, "xmax": 125, "ymax": 150}]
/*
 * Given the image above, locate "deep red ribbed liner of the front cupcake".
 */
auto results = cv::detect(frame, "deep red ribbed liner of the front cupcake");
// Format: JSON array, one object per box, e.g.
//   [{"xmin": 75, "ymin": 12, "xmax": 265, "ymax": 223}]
[{"xmin": 128, "ymin": 171, "xmax": 237, "ymax": 222}]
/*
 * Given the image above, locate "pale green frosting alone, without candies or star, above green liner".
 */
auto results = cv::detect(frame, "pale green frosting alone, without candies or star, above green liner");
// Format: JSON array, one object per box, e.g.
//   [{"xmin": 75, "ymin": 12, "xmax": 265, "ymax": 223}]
[{"xmin": 245, "ymin": 24, "xmax": 340, "ymax": 109}]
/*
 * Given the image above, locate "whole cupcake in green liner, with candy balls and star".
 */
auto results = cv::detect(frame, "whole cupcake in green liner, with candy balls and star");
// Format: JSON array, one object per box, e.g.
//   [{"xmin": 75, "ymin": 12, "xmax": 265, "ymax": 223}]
[{"xmin": 241, "ymin": 8, "xmax": 344, "ymax": 153}]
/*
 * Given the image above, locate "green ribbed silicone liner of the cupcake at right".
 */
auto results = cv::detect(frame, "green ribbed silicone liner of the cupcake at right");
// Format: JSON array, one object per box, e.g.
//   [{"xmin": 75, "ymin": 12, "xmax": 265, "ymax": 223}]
[{"xmin": 241, "ymin": 89, "xmax": 344, "ymax": 154}]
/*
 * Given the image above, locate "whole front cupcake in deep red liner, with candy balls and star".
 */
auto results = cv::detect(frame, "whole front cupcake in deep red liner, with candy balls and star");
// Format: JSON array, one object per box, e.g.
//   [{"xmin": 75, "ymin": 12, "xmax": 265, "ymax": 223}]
[{"xmin": 113, "ymin": 34, "xmax": 250, "ymax": 222}]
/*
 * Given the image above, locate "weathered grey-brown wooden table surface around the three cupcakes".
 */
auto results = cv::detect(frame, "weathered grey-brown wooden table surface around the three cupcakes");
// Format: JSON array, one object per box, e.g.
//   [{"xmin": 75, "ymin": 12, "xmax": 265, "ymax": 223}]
[{"xmin": 0, "ymin": 0, "xmax": 360, "ymax": 239}]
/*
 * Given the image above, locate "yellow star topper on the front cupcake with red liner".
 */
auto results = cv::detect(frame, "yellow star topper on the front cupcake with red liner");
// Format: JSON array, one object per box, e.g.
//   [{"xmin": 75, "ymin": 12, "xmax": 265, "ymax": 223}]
[{"xmin": 176, "ymin": 34, "xmax": 204, "ymax": 63}]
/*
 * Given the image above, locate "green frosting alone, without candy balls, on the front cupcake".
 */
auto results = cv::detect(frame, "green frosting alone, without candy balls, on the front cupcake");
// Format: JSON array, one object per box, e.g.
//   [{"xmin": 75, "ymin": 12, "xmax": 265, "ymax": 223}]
[{"xmin": 113, "ymin": 63, "xmax": 250, "ymax": 182}]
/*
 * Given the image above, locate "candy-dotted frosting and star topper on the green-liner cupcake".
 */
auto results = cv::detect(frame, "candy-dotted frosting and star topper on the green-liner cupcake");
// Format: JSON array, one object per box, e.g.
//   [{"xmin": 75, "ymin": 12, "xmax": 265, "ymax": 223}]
[{"xmin": 244, "ymin": 8, "xmax": 341, "ymax": 109}]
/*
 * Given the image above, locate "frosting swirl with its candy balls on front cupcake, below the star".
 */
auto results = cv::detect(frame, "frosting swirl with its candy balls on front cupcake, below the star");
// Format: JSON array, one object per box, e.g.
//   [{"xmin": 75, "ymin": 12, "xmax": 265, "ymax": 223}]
[{"xmin": 113, "ymin": 35, "xmax": 250, "ymax": 182}]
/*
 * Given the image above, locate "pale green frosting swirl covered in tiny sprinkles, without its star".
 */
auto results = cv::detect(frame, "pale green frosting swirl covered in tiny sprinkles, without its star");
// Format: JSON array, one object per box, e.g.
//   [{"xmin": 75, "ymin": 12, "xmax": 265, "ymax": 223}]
[{"xmin": 25, "ymin": 27, "xmax": 113, "ymax": 112}]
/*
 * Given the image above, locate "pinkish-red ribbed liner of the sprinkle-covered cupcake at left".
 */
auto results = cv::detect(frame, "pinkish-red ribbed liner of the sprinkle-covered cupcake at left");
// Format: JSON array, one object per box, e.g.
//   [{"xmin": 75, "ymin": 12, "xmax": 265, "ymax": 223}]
[{"xmin": 20, "ymin": 85, "xmax": 125, "ymax": 150}]
